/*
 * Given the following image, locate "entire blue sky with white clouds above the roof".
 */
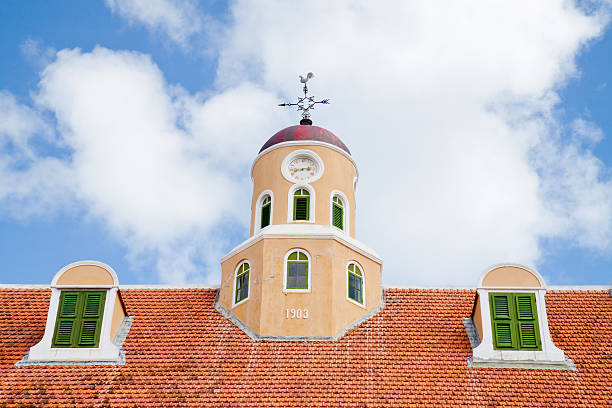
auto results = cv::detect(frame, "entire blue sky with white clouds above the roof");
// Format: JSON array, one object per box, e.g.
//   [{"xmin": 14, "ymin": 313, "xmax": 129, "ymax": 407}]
[{"xmin": 0, "ymin": 0, "xmax": 612, "ymax": 286}]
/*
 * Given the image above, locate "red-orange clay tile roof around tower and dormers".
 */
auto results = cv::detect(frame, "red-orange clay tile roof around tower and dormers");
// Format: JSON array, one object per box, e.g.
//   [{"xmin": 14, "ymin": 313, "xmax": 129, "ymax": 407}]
[{"xmin": 0, "ymin": 289, "xmax": 612, "ymax": 407}]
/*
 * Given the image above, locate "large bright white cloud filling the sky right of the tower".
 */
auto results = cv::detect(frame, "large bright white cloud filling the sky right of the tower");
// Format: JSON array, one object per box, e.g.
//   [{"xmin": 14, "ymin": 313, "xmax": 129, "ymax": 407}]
[{"xmin": 213, "ymin": 1, "xmax": 612, "ymax": 284}]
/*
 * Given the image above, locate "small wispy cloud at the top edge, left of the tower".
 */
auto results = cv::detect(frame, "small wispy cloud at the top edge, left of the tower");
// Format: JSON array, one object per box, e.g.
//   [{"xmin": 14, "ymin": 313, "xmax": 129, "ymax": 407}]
[{"xmin": 105, "ymin": 0, "xmax": 202, "ymax": 46}]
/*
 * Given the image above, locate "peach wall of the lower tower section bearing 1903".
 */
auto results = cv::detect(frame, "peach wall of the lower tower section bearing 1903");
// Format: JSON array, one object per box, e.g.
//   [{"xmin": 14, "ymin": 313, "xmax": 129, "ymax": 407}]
[{"xmin": 219, "ymin": 238, "xmax": 381, "ymax": 336}]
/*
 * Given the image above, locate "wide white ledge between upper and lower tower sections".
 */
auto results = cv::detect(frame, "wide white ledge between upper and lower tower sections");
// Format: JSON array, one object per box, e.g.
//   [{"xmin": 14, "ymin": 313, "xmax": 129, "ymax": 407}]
[{"xmin": 221, "ymin": 224, "xmax": 383, "ymax": 265}]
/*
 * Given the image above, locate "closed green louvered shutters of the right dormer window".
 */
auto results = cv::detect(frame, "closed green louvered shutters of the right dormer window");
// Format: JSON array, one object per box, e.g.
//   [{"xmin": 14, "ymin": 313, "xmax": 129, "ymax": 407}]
[{"xmin": 489, "ymin": 293, "xmax": 542, "ymax": 350}]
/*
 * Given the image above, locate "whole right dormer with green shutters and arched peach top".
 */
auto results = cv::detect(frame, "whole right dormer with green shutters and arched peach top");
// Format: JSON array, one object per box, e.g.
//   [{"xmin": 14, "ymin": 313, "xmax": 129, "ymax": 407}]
[{"xmin": 471, "ymin": 264, "xmax": 575, "ymax": 369}]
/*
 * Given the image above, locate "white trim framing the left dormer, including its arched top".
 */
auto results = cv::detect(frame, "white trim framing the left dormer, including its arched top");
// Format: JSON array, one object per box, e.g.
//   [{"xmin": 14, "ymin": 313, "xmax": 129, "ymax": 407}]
[{"xmin": 28, "ymin": 261, "xmax": 120, "ymax": 361}]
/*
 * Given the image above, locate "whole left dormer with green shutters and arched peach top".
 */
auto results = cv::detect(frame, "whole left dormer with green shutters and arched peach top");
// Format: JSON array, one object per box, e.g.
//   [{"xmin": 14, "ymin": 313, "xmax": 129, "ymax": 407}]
[{"xmin": 21, "ymin": 261, "xmax": 131, "ymax": 364}]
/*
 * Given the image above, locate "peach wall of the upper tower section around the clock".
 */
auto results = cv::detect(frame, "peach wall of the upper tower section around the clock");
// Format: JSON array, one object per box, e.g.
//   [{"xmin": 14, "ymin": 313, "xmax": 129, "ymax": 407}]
[{"xmin": 251, "ymin": 142, "xmax": 357, "ymax": 237}]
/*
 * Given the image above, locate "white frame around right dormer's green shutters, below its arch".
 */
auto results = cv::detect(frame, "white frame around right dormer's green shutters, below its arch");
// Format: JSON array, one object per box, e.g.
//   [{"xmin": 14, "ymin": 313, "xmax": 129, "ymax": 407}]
[{"xmin": 472, "ymin": 288, "xmax": 567, "ymax": 364}]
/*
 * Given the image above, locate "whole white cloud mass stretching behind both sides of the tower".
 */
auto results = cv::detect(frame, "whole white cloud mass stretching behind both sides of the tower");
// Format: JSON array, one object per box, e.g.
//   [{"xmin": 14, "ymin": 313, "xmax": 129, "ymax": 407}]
[{"xmin": 0, "ymin": 0, "xmax": 612, "ymax": 284}]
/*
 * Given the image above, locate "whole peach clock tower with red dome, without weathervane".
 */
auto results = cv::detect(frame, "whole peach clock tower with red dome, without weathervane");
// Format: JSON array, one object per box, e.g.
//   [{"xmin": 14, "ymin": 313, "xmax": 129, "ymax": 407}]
[{"xmin": 217, "ymin": 125, "xmax": 382, "ymax": 339}]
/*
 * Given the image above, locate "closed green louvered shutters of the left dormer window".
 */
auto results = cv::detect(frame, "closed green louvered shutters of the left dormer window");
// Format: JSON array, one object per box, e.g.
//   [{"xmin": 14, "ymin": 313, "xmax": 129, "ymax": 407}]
[{"xmin": 51, "ymin": 290, "xmax": 106, "ymax": 348}]
